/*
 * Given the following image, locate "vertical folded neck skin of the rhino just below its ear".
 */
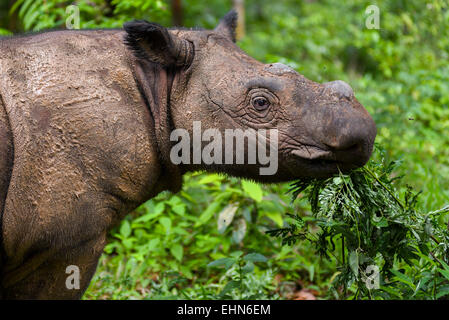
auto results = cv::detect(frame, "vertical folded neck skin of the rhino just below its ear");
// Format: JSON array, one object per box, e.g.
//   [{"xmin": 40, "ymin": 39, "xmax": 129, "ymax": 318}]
[{"xmin": 134, "ymin": 59, "xmax": 182, "ymax": 193}]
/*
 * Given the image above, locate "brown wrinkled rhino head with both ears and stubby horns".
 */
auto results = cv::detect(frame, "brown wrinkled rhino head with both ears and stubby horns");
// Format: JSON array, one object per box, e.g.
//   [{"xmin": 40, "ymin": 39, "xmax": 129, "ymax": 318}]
[{"xmin": 124, "ymin": 11, "xmax": 376, "ymax": 189}]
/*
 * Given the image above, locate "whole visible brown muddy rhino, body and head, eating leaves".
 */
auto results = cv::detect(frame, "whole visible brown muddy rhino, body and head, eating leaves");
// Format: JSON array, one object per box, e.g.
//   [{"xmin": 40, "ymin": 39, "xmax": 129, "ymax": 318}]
[{"xmin": 0, "ymin": 12, "xmax": 376, "ymax": 299}]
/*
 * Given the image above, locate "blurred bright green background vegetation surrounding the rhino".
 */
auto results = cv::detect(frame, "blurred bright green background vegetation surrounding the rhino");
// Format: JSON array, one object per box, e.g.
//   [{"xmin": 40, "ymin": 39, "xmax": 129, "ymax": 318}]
[{"xmin": 0, "ymin": 0, "xmax": 449, "ymax": 299}]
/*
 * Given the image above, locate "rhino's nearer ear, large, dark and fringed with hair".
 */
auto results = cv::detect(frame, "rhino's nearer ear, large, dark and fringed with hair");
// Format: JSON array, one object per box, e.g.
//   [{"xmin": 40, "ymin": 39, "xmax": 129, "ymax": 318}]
[{"xmin": 123, "ymin": 20, "xmax": 194, "ymax": 67}]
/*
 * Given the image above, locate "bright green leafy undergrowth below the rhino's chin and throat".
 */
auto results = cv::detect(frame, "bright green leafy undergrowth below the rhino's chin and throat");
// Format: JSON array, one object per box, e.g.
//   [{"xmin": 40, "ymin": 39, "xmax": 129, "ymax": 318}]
[{"xmin": 85, "ymin": 173, "xmax": 298, "ymax": 299}]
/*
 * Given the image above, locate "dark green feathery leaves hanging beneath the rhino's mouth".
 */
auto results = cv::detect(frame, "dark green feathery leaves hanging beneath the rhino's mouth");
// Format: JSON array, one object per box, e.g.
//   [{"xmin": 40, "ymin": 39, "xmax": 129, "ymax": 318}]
[{"xmin": 268, "ymin": 146, "xmax": 449, "ymax": 299}]
